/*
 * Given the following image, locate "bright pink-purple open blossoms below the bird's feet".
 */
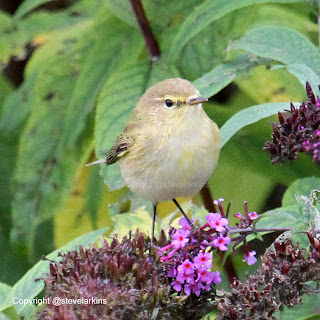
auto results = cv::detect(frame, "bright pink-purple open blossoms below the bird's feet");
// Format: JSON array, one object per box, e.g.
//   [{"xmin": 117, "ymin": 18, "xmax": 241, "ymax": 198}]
[{"xmin": 158, "ymin": 199, "xmax": 231, "ymax": 296}]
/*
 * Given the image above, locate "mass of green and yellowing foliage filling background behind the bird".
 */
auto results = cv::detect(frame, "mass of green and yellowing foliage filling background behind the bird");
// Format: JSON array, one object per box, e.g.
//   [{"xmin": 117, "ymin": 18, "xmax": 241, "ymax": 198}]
[{"xmin": 0, "ymin": 0, "xmax": 320, "ymax": 317}]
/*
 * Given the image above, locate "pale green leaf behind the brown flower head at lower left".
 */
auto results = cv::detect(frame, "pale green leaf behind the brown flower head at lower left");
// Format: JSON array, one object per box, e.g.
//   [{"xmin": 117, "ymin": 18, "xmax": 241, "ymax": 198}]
[{"xmin": 0, "ymin": 228, "xmax": 108, "ymax": 314}]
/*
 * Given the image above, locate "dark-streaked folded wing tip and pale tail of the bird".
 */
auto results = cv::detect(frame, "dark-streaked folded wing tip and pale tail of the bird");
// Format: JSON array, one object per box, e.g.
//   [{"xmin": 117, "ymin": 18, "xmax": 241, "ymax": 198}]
[{"xmin": 86, "ymin": 134, "xmax": 134, "ymax": 166}]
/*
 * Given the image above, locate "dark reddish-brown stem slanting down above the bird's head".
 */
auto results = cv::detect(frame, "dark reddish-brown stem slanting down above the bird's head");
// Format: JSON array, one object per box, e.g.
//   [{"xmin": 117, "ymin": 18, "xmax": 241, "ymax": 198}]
[{"xmin": 130, "ymin": 0, "xmax": 161, "ymax": 61}]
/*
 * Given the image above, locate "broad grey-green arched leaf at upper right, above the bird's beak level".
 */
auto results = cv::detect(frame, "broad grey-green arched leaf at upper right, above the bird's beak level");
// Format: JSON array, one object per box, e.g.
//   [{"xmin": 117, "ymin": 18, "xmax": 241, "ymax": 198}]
[{"xmin": 231, "ymin": 26, "xmax": 320, "ymax": 89}]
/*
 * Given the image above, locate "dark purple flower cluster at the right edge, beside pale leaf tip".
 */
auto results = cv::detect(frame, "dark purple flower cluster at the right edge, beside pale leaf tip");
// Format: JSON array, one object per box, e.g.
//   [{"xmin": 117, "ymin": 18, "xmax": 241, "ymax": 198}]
[{"xmin": 264, "ymin": 82, "xmax": 320, "ymax": 164}]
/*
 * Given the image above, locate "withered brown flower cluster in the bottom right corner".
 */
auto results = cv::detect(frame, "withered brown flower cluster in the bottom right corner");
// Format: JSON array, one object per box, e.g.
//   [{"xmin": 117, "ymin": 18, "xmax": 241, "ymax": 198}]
[{"xmin": 216, "ymin": 236, "xmax": 320, "ymax": 320}]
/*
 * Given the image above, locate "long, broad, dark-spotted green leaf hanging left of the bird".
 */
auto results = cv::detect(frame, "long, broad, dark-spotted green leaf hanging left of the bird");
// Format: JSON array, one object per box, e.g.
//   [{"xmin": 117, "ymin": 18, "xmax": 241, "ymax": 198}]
[{"xmin": 11, "ymin": 7, "xmax": 143, "ymax": 261}]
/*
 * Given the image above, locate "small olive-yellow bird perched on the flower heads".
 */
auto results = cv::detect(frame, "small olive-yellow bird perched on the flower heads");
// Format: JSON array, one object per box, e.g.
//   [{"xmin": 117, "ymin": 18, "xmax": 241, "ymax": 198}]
[{"xmin": 87, "ymin": 78, "xmax": 221, "ymax": 242}]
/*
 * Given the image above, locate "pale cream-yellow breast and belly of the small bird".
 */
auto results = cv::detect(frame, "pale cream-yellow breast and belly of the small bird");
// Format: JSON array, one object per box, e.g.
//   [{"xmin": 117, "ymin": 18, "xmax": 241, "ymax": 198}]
[{"xmin": 120, "ymin": 107, "xmax": 220, "ymax": 203}]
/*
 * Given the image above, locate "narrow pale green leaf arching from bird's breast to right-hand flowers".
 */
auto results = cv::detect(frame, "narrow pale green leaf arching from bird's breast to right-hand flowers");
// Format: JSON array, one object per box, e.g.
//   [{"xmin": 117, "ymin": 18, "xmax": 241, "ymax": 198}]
[{"xmin": 220, "ymin": 102, "xmax": 298, "ymax": 147}]
